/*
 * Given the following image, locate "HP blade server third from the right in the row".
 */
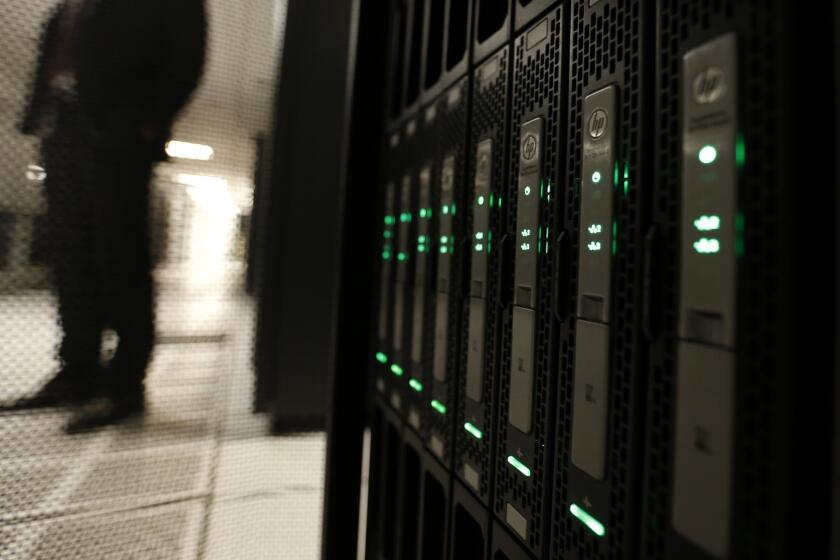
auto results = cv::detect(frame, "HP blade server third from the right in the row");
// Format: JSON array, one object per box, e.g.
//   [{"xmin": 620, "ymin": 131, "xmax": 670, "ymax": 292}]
[{"xmin": 493, "ymin": 6, "xmax": 567, "ymax": 558}]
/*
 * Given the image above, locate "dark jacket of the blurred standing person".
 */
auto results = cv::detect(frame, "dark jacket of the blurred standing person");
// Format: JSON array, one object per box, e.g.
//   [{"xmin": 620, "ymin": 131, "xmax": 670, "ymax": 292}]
[{"xmin": 20, "ymin": 0, "xmax": 207, "ymax": 153}]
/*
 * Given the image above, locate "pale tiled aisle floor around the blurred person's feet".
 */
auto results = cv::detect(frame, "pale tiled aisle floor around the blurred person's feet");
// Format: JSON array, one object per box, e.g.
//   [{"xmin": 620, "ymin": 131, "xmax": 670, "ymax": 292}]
[{"xmin": 0, "ymin": 288, "xmax": 324, "ymax": 559}]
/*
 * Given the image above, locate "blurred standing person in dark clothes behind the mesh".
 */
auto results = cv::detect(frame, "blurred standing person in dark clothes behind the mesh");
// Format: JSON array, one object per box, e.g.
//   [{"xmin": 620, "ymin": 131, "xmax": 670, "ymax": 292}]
[{"xmin": 19, "ymin": 0, "xmax": 207, "ymax": 433}]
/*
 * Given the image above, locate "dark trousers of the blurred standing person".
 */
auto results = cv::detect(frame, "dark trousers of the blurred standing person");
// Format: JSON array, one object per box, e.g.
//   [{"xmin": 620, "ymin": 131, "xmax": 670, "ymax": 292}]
[{"xmin": 42, "ymin": 106, "xmax": 154, "ymax": 395}]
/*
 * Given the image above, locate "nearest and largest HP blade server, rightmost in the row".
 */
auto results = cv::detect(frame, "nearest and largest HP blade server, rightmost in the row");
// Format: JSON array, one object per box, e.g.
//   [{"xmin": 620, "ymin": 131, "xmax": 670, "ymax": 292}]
[{"xmin": 642, "ymin": 0, "xmax": 836, "ymax": 560}]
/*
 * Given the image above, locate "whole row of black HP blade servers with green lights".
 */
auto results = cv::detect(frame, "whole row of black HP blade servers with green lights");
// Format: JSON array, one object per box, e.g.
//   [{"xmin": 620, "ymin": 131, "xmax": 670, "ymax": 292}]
[{"xmin": 366, "ymin": 0, "xmax": 835, "ymax": 560}]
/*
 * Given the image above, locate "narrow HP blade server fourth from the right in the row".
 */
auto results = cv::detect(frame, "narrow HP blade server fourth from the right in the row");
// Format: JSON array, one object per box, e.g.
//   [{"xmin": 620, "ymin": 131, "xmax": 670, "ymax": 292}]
[{"xmin": 454, "ymin": 47, "xmax": 511, "ymax": 507}]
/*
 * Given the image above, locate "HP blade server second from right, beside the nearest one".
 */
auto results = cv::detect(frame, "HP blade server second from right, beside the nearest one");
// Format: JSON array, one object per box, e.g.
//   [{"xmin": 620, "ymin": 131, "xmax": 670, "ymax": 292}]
[{"xmin": 552, "ymin": 0, "xmax": 653, "ymax": 559}]
